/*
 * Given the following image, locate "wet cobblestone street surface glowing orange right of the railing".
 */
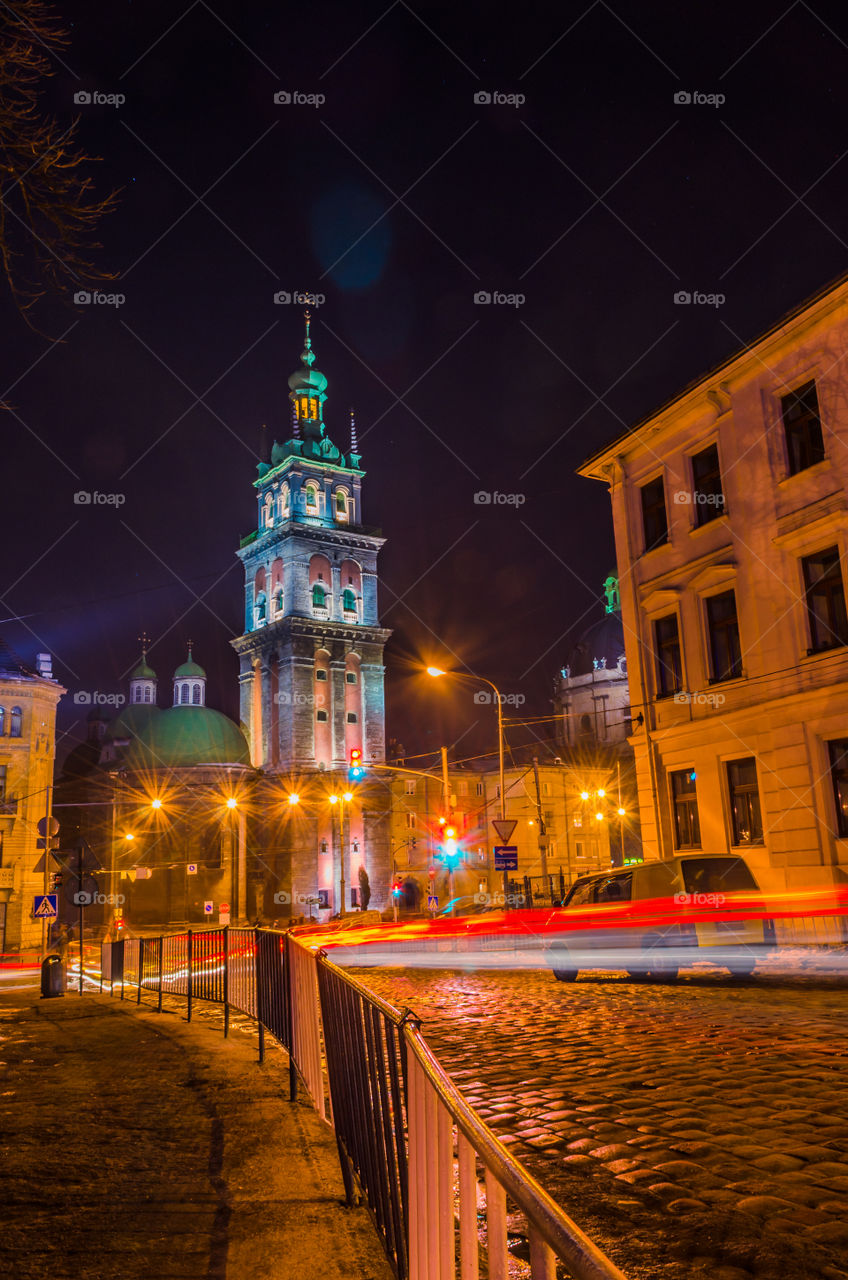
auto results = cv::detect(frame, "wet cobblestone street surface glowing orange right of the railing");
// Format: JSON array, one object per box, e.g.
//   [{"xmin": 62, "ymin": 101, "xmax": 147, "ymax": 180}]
[{"xmin": 359, "ymin": 969, "xmax": 848, "ymax": 1280}]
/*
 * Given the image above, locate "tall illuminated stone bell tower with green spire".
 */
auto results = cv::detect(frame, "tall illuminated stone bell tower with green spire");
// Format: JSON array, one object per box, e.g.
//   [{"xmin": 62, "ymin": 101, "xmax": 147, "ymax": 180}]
[{"xmin": 232, "ymin": 312, "xmax": 391, "ymax": 915}]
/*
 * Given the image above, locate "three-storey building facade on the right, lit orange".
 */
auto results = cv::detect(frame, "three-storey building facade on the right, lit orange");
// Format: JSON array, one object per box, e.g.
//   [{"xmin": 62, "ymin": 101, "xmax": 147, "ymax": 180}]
[{"xmin": 580, "ymin": 280, "xmax": 848, "ymax": 891}]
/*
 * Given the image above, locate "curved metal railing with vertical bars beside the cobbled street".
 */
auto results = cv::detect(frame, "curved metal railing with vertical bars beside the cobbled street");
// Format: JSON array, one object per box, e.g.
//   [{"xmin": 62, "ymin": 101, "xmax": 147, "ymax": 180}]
[{"xmin": 101, "ymin": 927, "xmax": 625, "ymax": 1280}]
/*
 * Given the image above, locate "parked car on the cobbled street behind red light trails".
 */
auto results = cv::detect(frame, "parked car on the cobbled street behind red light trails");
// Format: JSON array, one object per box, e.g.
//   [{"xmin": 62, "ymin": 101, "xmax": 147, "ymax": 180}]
[{"xmin": 546, "ymin": 852, "xmax": 775, "ymax": 982}]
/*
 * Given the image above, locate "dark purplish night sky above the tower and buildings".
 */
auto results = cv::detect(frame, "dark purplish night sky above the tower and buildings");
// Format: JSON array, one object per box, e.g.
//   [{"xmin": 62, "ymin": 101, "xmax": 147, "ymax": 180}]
[{"xmin": 0, "ymin": 0, "xmax": 848, "ymax": 756}]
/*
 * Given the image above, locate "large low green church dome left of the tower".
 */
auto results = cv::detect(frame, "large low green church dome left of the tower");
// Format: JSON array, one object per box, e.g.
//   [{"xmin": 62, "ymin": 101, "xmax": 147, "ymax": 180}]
[{"xmin": 124, "ymin": 705, "xmax": 250, "ymax": 769}]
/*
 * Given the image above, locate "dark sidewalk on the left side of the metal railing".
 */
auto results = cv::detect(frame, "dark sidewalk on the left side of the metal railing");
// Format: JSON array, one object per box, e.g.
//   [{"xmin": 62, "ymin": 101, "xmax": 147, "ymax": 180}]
[{"xmin": 0, "ymin": 991, "xmax": 391, "ymax": 1280}]
